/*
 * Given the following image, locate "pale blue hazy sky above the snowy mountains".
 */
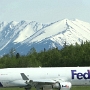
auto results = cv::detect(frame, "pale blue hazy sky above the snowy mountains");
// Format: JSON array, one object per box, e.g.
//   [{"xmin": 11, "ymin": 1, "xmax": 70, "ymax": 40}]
[{"xmin": 0, "ymin": 0, "xmax": 90, "ymax": 23}]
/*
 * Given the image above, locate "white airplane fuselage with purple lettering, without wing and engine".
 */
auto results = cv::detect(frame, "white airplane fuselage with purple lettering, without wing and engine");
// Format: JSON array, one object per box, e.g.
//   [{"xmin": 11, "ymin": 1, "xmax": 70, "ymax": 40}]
[{"xmin": 0, "ymin": 67, "xmax": 90, "ymax": 87}]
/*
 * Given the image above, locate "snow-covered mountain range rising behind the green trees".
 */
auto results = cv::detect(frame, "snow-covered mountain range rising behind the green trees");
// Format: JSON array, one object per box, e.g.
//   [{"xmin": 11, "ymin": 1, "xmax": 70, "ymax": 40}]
[{"xmin": 0, "ymin": 19, "xmax": 90, "ymax": 55}]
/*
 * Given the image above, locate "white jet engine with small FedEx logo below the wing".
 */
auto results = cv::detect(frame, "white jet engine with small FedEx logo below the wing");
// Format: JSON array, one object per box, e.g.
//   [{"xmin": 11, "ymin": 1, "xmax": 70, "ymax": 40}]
[{"xmin": 52, "ymin": 82, "xmax": 72, "ymax": 90}]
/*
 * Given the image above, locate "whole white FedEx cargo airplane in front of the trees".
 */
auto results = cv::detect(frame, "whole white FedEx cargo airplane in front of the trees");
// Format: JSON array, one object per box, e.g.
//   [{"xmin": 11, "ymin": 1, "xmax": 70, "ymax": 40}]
[{"xmin": 0, "ymin": 67, "xmax": 90, "ymax": 90}]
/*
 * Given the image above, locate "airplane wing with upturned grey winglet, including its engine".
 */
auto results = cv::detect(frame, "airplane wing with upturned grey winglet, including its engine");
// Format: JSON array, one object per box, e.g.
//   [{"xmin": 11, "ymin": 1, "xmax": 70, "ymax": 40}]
[{"xmin": 21, "ymin": 73, "xmax": 72, "ymax": 90}]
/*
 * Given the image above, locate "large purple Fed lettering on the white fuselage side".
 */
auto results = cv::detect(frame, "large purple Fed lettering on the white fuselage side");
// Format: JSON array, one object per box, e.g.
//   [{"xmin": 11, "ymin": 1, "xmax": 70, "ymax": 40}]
[{"xmin": 71, "ymin": 70, "xmax": 90, "ymax": 80}]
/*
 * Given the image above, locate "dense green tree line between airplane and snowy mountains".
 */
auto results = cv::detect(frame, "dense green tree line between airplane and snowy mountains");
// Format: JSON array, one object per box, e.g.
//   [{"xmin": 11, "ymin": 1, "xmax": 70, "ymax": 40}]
[{"xmin": 0, "ymin": 41, "xmax": 90, "ymax": 68}]
